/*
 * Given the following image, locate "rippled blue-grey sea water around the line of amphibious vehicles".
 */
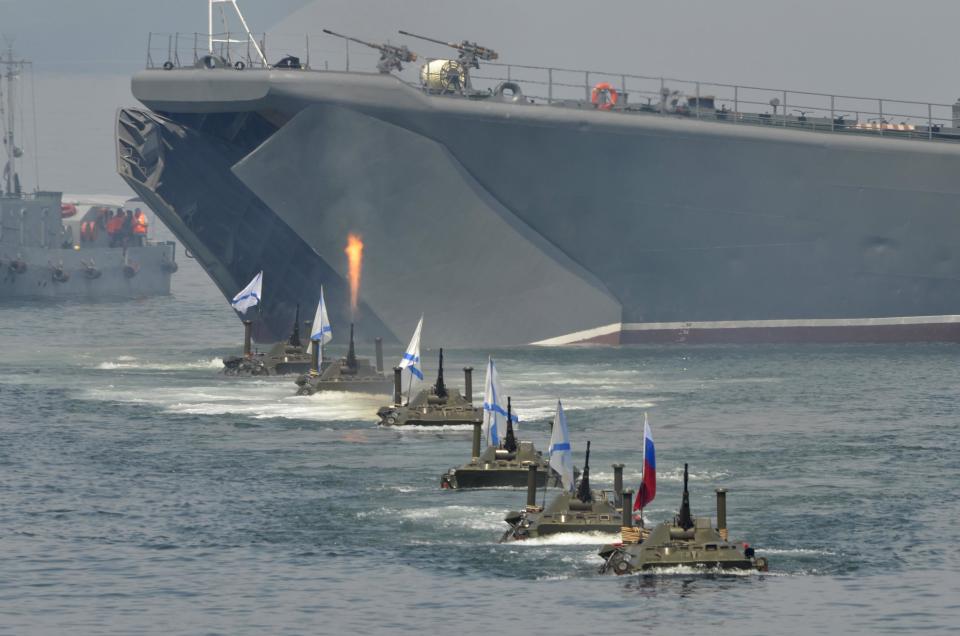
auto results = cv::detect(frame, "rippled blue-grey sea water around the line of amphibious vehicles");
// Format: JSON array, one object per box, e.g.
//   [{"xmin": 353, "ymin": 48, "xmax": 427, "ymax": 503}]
[{"xmin": 0, "ymin": 226, "xmax": 960, "ymax": 634}]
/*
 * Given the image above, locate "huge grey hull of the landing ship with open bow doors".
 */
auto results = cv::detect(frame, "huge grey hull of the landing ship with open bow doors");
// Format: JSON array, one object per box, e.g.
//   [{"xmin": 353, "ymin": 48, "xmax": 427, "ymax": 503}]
[{"xmin": 118, "ymin": 69, "xmax": 960, "ymax": 346}]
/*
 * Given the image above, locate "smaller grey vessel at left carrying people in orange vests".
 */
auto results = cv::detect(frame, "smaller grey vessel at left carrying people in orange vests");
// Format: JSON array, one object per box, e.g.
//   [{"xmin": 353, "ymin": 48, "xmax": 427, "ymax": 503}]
[{"xmin": 0, "ymin": 47, "xmax": 177, "ymax": 300}]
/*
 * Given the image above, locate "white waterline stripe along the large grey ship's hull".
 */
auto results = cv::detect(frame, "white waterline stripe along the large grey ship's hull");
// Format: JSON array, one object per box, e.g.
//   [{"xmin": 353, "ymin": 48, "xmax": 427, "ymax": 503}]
[{"xmin": 531, "ymin": 315, "xmax": 960, "ymax": 347}]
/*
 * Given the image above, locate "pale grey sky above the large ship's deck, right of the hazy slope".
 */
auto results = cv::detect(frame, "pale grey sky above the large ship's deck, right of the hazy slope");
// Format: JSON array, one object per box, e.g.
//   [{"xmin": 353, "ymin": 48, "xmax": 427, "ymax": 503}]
[{"xmin": 282, "ymin": 0, "xmax": 960, "ymax": 103}]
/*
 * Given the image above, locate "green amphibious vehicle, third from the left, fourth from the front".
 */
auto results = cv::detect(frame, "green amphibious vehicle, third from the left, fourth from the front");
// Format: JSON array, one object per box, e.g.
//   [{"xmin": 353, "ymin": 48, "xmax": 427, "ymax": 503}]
[{"xmin": 377, "ymin": 349, "xmax": 483, "ymax": 426}]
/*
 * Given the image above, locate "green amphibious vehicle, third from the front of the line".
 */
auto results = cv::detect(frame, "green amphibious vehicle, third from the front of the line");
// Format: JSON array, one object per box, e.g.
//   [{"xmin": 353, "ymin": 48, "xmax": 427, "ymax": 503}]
[{"xmin": 440, "ymin": 397, "xmax": 561, "ymax": 489}]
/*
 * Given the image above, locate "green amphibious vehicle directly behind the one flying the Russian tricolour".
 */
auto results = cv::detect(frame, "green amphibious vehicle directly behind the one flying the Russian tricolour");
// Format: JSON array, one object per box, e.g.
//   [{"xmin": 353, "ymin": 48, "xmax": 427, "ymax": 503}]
[{"xmin": 500, "ymin": 442, "xmax": 623, "ymax": 543}]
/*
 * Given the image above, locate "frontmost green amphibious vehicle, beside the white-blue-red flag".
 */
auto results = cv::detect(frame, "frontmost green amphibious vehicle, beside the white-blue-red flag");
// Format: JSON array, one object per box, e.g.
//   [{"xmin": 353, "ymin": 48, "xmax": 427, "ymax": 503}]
[{"xmin": 600, "ymin": 464, "xmax": 768, "ymax": 574}]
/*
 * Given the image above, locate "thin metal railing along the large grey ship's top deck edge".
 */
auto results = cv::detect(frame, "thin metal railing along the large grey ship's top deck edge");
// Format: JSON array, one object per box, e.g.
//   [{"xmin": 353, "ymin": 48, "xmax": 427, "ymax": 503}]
[{"xmin": 141, "ymin": 33, "xmax": 960, "ymax": 141}]
